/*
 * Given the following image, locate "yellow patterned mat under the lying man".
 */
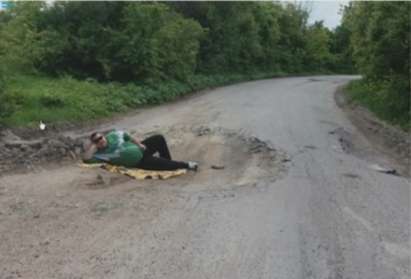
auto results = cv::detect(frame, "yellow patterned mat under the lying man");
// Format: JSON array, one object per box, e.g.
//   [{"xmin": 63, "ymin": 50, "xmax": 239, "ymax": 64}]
[{"xmin": 79, "ymin": 163, "xmax": 187, "ymax": 179}]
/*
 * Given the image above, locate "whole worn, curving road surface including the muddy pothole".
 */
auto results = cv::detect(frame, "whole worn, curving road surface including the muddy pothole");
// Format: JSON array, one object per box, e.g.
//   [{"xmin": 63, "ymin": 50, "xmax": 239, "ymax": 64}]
[{"xmin": 0, "ymin": 76, "xmax": 410, "ymax": 279}]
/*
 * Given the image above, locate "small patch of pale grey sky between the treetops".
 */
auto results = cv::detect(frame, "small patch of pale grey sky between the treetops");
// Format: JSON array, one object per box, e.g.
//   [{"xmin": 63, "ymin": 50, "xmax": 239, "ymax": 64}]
[{"xmin": 301, "ymin": 1, "xmax": 349, "ymax": 29}]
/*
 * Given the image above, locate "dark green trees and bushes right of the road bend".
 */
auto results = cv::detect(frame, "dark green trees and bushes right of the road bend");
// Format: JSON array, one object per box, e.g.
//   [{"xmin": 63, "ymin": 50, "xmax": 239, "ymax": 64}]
[{"xmin": 341, "ymin": 1, "xmax": 411, "ymax": 127}]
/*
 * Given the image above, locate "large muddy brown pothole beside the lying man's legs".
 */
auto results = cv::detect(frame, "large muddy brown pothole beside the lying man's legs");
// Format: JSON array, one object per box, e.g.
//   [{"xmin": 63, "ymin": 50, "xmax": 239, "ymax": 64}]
[{"xmin": 156, "ymin": 126, "xmax": 287, "ymax": 191}]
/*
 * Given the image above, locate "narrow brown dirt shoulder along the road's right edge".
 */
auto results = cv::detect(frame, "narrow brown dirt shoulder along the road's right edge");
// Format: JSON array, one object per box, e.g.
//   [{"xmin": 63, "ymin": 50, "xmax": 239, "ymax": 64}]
[{"xmin": 335, "ymin": 87, "xmax": 411, "ymax": 176}]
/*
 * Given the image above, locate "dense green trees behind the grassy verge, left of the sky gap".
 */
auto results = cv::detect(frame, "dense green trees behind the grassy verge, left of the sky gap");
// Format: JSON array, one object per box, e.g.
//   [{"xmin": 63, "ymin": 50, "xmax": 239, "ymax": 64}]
[{"xmin": 0, "ymin": 1, "xmax": 350, "ymax": 81}]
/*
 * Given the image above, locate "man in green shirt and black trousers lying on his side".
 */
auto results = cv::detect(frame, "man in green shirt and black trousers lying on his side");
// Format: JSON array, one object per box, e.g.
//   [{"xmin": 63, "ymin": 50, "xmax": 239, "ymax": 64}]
[{"xmin": 83, "ymin": 130, "xmax": 198, "ymax": 171}]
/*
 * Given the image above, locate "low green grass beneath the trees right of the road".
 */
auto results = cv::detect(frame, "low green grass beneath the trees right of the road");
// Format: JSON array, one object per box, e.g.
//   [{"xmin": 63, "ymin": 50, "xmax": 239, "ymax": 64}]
[{"xmin": 345, "ymin": 80, "xmax": 411, "ymax": 131}]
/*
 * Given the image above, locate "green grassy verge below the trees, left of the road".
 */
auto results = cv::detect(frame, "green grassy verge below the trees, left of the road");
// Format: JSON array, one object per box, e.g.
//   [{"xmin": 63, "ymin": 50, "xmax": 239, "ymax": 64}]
[{"xmin": 0, "ymin": 70, "xmax": 283, "ymax": 127}]
